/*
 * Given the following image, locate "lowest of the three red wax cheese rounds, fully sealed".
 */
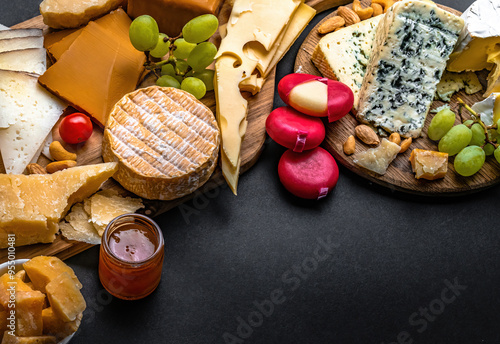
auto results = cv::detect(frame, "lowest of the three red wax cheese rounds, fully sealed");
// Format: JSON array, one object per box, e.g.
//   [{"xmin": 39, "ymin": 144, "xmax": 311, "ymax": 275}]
[{"xmin": 278, "ymin": 147, "xmax": 339, "ymax": 199}]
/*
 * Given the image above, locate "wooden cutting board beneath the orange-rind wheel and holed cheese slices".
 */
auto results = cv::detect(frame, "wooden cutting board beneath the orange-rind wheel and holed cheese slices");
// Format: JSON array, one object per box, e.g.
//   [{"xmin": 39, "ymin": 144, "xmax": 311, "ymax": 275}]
[{"xmin": 0, "ymin": 0, "xmax": 351, "ymax": 262}]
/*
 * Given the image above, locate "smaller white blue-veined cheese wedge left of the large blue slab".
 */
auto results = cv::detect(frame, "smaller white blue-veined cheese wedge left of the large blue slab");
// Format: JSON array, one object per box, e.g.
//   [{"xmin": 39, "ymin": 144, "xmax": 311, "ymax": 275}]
[{"xmin": 312, "ymin": 15, "xmax": 383, "ymax": 109}]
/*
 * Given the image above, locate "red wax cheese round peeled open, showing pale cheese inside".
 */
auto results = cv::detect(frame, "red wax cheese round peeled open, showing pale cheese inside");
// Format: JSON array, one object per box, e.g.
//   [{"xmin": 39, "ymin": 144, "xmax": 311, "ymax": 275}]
[{"xmin": 278, "ymin": 73, "xmax": 354, "ymax": 122}]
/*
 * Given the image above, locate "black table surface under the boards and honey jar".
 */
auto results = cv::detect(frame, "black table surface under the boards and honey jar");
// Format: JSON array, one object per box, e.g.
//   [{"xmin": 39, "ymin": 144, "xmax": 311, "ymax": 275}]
[{"xmin": 0, "ymin": 0, "xmax": 500, "ymax": 344}]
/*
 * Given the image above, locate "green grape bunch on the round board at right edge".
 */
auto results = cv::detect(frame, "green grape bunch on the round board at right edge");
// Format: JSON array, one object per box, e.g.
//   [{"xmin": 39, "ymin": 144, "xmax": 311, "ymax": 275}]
[{"xmin": 427, "ymin": 99, "xmax": 500, "ymax": 177}]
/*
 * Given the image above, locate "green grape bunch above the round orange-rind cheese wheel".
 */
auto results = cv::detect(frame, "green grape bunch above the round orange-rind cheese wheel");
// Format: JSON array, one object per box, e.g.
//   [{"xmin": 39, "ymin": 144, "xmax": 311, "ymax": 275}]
[{"xmin": 129, "ymin": 14, "xmax": 219, "ymax": 99}]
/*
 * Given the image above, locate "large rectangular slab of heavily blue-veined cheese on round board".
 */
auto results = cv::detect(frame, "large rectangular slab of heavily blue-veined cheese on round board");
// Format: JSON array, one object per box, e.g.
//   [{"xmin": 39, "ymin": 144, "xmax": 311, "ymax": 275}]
[{"xmin": 357, "ymin": 0, "xmax": 464, "ymax": 138}]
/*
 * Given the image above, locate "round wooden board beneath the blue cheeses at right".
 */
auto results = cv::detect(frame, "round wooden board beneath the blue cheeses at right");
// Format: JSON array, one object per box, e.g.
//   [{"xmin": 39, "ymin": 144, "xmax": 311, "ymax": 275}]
[{"xmin": 294, "ymin": 0, "xmax": 500, "ymax": 196}]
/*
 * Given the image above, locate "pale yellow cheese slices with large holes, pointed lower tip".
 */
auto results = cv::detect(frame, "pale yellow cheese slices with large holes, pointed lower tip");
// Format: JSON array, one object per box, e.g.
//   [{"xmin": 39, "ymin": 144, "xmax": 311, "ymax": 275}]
[{"xmin": 214, "ymin": 0, "xmax": 316, "ymax": 194}]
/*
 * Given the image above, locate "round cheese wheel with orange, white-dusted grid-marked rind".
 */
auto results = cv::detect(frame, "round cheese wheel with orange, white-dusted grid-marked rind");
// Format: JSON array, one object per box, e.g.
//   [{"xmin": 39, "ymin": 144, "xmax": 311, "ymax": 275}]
[{"xmin": 102, "ymin": 86, "xmax": 220, "ymax": 200}]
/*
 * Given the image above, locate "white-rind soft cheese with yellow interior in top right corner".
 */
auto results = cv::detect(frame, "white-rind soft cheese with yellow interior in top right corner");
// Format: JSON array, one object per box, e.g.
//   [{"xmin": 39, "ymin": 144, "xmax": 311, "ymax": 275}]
[{"xmin": 447, "ymin": 0, "xmax": 500, "ymax": 97}]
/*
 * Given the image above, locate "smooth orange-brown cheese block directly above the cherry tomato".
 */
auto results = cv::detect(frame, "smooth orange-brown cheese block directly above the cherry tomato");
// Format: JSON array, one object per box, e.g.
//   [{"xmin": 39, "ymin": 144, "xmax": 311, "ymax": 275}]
[{"xmin": 38, "ymin": 11, "xmax": 145, "ymax": 126}]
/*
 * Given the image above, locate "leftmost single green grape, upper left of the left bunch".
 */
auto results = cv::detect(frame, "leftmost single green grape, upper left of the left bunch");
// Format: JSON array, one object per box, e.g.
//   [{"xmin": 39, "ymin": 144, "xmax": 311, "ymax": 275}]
[{"xmin": 129, "ymin": 15, "xmax": 160, "ymax": 51}]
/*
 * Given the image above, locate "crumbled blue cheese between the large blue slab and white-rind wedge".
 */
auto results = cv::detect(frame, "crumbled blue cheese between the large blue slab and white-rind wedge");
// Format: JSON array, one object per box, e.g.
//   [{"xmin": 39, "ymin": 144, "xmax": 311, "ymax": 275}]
[{"xmin": 436, "ymin": 72, "xmax": 483, "ymax": 101}]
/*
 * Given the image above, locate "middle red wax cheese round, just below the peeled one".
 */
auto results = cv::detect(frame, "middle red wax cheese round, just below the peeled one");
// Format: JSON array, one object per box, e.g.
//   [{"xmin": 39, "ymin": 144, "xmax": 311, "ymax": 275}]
[{"xmin": 266, "ymin": 106, "xmax": 325, "ymax": 152}]
